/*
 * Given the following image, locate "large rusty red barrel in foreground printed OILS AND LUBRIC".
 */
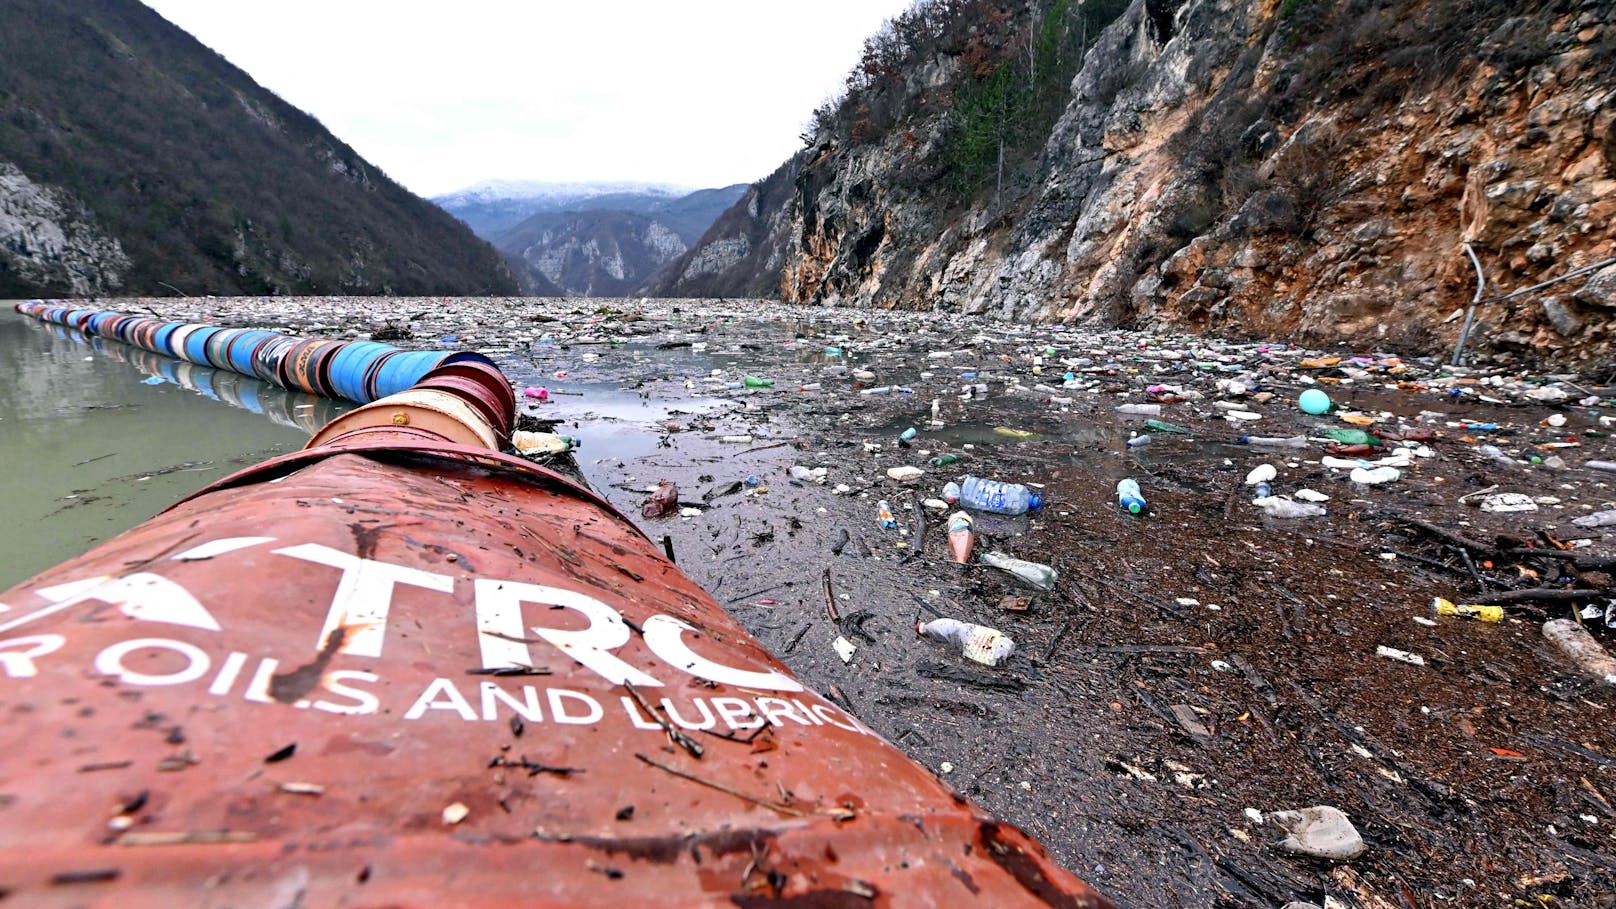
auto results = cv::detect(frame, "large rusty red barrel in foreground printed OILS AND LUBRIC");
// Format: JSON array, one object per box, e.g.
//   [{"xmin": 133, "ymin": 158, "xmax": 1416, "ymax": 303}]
[{"xmin": 0, "ymin": 384, "xmax": 1107, "ymax": 909}]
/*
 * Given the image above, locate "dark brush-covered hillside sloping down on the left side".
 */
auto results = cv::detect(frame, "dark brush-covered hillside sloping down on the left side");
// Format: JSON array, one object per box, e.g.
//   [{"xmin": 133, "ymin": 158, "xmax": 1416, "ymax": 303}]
[{"xmin": 0, "ymin": 0, "xmax": 517, "ymax": 298}]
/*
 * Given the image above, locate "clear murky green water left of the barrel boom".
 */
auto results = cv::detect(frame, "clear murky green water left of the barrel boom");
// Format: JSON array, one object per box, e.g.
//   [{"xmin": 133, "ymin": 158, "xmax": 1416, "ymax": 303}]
[{"xmin": 0, "ymin": 304, "xmax": 344, "ymax": 590}]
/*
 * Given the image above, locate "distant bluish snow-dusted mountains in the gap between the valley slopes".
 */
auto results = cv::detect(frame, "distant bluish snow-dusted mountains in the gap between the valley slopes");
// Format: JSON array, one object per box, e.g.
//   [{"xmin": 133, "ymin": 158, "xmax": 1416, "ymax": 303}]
[{"xmin": 433, "ymin": 180, "xmax": 748, "ymax": 296}]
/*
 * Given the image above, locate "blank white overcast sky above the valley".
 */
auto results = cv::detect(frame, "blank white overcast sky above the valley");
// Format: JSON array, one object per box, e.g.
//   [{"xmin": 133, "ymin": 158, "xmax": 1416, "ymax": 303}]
[{"xmin": 145, "ymin": 0, "xmax": 910, "ymax": 196}]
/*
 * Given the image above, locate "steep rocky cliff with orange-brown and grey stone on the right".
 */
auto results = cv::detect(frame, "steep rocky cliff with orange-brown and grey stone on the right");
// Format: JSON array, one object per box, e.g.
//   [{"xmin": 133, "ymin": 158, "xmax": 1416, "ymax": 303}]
[{"xmin": 674, "ymin": 0, "xmax": 1616, "ymax": 362}]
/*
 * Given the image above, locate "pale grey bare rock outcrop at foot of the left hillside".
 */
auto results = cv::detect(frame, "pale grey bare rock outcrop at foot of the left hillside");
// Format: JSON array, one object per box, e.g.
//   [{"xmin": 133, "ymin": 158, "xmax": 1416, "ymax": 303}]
[{"xmin": 0, "ymin": 162, "xmax": 129, "ymax": 296}]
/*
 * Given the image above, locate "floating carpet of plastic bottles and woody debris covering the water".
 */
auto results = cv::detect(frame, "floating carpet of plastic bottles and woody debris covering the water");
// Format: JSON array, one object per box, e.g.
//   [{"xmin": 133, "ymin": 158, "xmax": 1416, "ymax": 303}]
[{"xmin": 56, "ymin": 298, "xmax": 1616, "ymax": 907}]
